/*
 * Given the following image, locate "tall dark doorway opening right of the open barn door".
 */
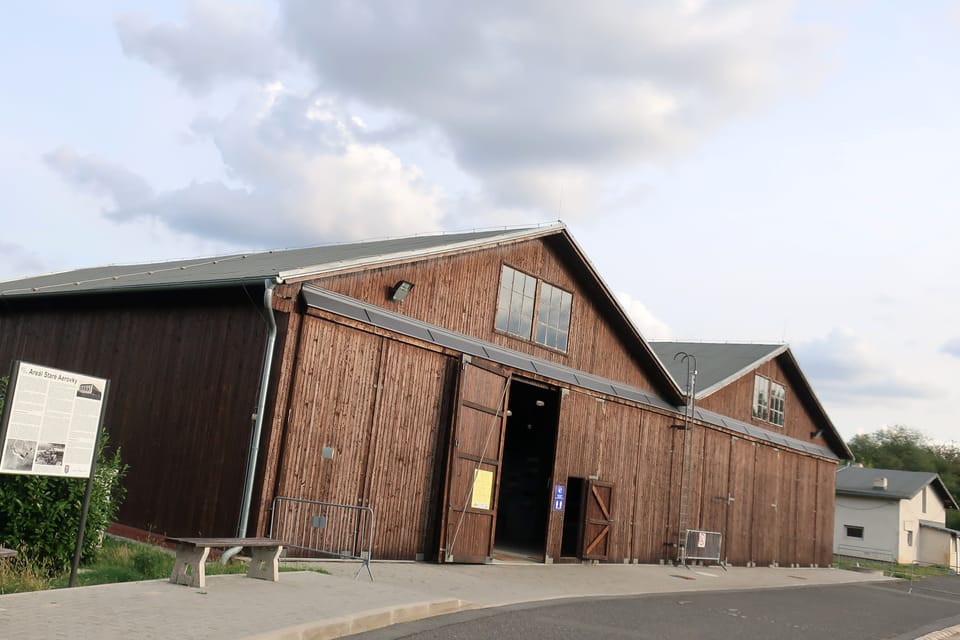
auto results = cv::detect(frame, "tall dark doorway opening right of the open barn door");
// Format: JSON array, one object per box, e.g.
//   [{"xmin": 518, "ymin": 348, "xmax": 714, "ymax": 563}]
[{"xmin": 494, "ymin": 378, "xmax": 560, "ymax": 561}]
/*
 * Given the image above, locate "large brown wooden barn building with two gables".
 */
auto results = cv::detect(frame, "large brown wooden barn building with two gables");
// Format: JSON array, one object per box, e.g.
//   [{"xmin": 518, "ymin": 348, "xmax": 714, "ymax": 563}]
[{"xmin": 0, "ymin": 224, "xmax": 849, "ymax": 565}]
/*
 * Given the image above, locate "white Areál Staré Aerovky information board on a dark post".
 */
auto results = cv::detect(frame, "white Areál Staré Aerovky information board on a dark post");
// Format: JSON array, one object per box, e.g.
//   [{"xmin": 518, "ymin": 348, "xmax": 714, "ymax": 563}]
[{"xmin": 0, "ymin": 361, "xmax": 110, "ymax": 587}]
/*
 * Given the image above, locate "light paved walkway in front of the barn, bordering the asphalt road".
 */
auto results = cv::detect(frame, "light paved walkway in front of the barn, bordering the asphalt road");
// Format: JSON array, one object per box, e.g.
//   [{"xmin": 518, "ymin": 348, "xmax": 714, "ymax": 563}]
[{"xmin": 0, "ymin": 562, "xmax": 908, "ymax": 640}]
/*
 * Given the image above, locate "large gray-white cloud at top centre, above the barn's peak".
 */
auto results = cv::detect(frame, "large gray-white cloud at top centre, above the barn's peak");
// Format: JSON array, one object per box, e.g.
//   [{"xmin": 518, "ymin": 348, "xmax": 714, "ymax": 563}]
[{"xmin": 281, "ymin": 0, "xmax": 819, "ymax": 215}]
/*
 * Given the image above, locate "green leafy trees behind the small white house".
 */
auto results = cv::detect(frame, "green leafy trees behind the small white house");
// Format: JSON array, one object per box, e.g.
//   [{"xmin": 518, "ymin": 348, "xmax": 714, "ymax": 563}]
[{"xmin": 848, "ymin": 425, "xmax": 960, "ymax": 530}]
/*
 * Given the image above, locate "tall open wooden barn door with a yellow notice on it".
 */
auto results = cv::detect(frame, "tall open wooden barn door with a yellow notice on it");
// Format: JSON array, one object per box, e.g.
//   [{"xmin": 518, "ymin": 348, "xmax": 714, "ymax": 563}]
[{"xmin": 440, "ymin": 357, "xmax": 510, "ymax": 563}]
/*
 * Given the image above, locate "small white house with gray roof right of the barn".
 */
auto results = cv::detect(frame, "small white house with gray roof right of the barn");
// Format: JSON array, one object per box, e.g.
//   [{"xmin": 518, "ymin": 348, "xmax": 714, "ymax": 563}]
[{"xmin": 834, "ymin": 466, "xmax": 960, "ymax": 570}]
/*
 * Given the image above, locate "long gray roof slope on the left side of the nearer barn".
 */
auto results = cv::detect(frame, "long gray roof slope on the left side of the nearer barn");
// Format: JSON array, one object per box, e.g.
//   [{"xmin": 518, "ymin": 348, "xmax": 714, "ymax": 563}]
[{"xmin": 0, "ymin": 223, "xmax": 565, "ymax": 297}]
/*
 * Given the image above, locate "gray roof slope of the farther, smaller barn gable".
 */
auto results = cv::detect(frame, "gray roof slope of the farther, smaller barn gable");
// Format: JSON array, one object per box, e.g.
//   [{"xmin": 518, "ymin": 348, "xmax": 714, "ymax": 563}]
[{"xmin": 650, "ymin": 341, "xmax": 787, "ymax": 399}]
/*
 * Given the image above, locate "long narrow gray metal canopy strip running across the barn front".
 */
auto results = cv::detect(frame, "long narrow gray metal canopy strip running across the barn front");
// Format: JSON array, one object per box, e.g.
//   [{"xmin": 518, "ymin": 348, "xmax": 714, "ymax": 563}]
[{"xmin": 302, "ymin": 284, "xmax": 839, "ymax": 460}]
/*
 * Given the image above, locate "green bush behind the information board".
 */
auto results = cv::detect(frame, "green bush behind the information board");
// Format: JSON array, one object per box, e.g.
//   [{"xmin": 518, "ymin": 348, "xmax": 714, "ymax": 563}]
[{"xmin": 0, "ymin": 378, "xmax": 127, "ymax": 574}]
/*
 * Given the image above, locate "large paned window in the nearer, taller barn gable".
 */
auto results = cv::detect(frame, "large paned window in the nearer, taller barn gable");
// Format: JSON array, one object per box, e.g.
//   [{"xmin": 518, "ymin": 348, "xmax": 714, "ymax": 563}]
[{"xmin": 494, "ymin": 265, "xmax": 573, "ymax": 352}]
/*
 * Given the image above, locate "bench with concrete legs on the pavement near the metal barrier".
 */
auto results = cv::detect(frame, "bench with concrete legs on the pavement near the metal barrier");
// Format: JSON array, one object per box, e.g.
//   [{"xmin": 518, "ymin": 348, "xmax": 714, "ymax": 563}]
[{"xmin": 167, "ymin": 538, "xmax": 283, "ymax": 589}]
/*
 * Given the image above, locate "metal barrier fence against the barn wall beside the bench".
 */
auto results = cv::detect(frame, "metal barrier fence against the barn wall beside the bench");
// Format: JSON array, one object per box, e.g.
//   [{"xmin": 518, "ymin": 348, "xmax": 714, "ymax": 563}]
[{"xmin": 270, "ymin": 496, "xmax": 374, "ymax": 581}]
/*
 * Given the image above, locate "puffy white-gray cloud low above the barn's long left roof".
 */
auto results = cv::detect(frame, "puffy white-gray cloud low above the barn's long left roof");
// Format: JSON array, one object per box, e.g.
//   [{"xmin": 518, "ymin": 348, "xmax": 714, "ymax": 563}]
[{"xmin": 47, "ymin": 86, "xmax": 442, "ymax": 247}]
